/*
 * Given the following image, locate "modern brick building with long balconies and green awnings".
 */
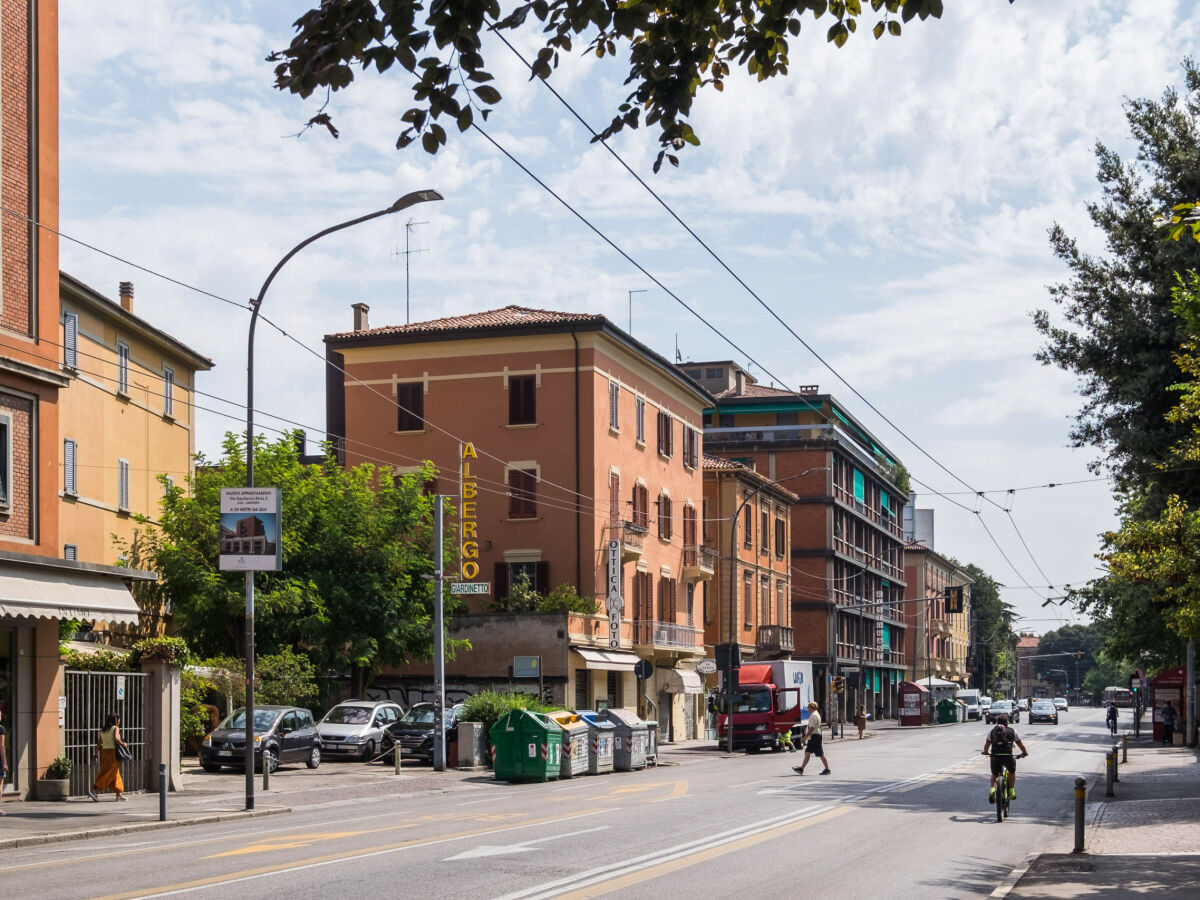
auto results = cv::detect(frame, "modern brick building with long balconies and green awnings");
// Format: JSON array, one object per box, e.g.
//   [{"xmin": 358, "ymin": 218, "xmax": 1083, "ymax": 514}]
[{"xmin": 680, "ymin": 360, "xmax": 907, "ymax": 721}]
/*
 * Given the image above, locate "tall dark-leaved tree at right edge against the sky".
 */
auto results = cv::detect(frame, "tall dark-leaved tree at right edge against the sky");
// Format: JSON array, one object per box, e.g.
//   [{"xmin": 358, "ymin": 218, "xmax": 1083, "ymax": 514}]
[{"xmin": 1033, "ymin": 58, "xmax": 1200, "ymax": 515}]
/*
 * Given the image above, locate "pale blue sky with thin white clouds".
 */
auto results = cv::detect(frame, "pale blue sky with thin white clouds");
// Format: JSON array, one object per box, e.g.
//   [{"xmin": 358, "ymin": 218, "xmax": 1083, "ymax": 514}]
[{"xmin": 59, "ymin": 0, "xmax": 1200, "ymax": 634}]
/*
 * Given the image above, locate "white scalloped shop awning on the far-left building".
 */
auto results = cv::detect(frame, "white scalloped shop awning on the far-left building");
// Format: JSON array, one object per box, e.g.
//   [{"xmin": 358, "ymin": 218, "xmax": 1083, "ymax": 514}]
[{"xmin": 0, "ymin": 566, "xmax": 140, "ymax": 625}]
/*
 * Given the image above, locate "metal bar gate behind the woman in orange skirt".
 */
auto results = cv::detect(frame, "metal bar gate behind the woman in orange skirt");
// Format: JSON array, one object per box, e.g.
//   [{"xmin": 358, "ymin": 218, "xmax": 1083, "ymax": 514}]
[{"xmin": 65, "ymin": 668, "xmax": 150, "ymax": 797}]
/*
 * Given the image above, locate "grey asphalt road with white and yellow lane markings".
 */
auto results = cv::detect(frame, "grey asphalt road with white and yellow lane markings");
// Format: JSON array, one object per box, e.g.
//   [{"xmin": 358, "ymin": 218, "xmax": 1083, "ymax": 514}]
[{"xmin": 0, "ymin": 709, "xmax": 1110, "ymax": 900}]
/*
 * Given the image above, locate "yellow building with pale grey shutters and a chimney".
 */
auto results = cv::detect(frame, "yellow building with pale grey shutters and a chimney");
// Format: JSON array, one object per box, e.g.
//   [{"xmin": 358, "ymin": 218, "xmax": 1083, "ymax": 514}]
[{"xmin": 56, "ymin": 272, "xmax": 212, "ymax": 634}]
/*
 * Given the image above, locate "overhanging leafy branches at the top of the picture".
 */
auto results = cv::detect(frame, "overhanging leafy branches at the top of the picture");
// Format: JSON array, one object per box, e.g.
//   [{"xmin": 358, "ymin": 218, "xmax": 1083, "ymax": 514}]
[{"xmin": 269, "ymin": 0, "xmax": 942, "ymax": 172}]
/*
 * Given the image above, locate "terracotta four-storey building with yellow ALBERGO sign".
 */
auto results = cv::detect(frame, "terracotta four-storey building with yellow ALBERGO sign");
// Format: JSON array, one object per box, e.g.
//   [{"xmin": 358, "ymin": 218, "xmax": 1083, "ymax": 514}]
[{"xmin": 325, "ymin": 304, "xmax": 714, "ymax": 739}]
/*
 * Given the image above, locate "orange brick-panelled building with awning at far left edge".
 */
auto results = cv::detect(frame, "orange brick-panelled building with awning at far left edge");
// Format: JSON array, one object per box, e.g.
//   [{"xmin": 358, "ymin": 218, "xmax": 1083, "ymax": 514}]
[{"xmin": 0, "ymin": 0, "xmax": 154, "ymax": 796}]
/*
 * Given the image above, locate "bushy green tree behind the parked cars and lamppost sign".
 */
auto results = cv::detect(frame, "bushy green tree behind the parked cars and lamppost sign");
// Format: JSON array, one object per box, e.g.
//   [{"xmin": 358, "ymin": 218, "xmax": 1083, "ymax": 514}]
[{"xmin": 148, "ymin": 434, "xmax": 466, "ymax": 692}]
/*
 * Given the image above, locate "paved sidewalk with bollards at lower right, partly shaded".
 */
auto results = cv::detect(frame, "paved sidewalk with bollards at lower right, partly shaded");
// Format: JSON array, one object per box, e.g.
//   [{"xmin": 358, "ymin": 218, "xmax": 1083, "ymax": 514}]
[{"xmin": 996, "ymin": 737, "xmax": 1200, "ymax": 900}]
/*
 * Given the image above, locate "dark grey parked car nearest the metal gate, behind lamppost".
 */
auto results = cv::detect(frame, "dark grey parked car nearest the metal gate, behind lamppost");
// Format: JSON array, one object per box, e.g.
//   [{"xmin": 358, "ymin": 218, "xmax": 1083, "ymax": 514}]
[{"xmin": 200, "ymin": 707, "xmax": 320, "ymax": 772}]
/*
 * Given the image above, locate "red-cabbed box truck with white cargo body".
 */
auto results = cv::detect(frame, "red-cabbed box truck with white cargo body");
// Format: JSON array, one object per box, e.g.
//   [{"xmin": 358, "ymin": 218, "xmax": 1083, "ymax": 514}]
[{"xmin": 716, "ymin": 659, "xmax": 812, "ymax": 754}]
